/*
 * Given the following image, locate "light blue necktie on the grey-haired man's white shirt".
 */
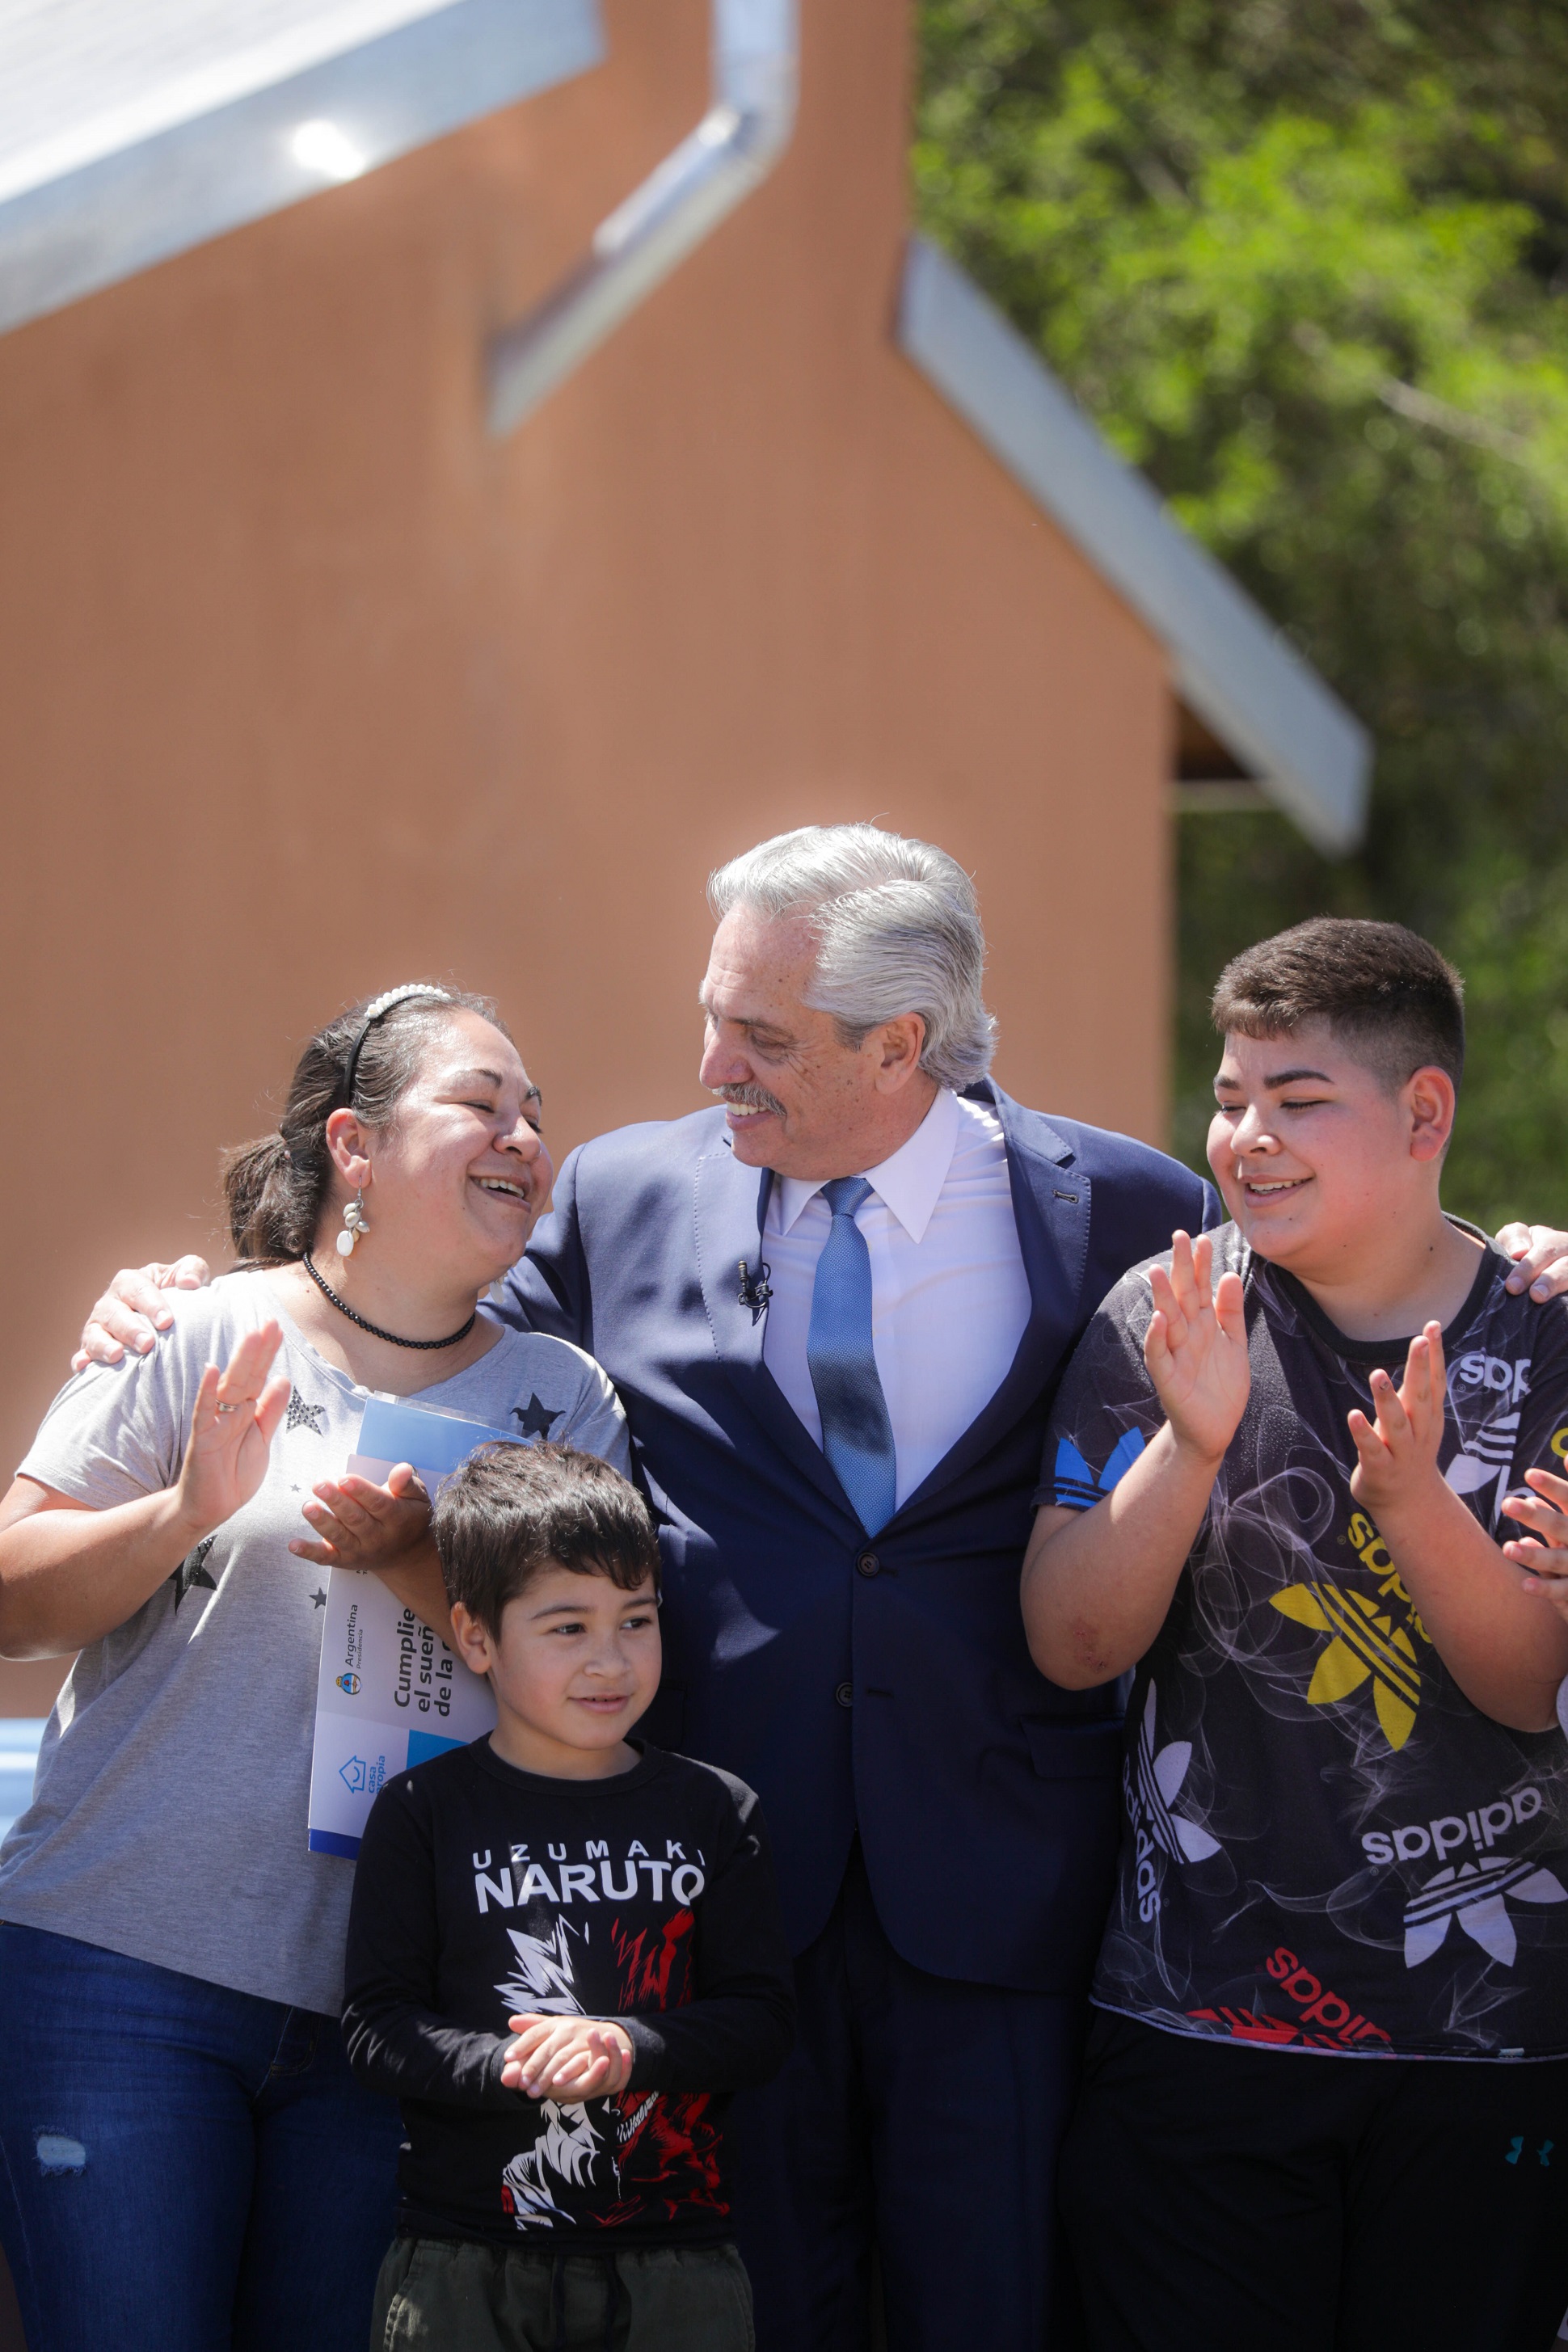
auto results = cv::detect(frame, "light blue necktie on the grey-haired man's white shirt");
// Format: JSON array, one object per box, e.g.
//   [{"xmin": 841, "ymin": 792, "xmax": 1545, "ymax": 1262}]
[{"xmin": 807, "ymin": 1176, "xmax": 898, "ymax": 1536}]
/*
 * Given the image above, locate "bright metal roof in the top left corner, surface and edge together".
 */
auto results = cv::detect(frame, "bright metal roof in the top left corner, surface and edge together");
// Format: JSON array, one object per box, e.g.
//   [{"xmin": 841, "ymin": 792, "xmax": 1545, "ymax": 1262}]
[{"xmin": 0, "ymin": 0, "xmax": 604, "ymax": 329}]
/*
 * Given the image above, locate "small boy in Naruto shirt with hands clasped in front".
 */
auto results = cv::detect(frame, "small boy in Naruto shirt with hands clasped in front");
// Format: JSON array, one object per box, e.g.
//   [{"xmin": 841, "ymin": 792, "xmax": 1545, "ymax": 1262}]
[{"xmin": 344, "ymin": 1444, "xmax": 792, "ymax": 2352}]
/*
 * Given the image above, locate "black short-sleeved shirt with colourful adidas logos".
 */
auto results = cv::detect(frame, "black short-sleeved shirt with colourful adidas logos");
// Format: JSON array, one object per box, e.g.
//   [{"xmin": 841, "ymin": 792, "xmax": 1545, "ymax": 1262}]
[{"xmin": 1035, "ymin": 1225, "xmax": 1568, "ymax": 2058}]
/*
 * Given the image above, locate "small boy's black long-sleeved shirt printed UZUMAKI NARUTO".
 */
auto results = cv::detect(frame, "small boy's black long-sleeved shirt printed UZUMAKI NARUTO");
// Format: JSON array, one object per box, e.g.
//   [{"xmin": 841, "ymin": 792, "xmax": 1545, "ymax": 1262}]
[{"xmin": 344, "ymin": 1740, "xmax": 795, "ymax": 2244}]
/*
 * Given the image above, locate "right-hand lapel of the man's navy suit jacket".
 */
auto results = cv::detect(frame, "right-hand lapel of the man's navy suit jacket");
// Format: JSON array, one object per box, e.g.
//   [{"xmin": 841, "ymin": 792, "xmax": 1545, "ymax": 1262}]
[{"xmin": 896, "ymin": 1080, "xmax": 1089, "ymax": 1524}]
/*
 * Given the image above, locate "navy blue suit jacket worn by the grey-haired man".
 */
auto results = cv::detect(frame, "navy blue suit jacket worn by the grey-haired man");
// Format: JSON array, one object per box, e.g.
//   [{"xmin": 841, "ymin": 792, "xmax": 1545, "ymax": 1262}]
[{"xmin": 499, "ymin": 1080, "xmax": 1218, "ymax": 1992}]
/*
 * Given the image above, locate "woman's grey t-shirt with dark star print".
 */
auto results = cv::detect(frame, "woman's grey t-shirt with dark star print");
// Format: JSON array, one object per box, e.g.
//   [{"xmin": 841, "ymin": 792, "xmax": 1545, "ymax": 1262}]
[{"xmin": 0, "ymin": 1272, "xmax": 630, "ymax": 2025}]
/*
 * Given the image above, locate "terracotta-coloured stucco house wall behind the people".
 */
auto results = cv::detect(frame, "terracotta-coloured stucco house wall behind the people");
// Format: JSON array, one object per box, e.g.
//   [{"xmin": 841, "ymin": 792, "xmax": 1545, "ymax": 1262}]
[{"xmin": 0, "ymin": 0, "xmax": 1169, "ymax": 1712}]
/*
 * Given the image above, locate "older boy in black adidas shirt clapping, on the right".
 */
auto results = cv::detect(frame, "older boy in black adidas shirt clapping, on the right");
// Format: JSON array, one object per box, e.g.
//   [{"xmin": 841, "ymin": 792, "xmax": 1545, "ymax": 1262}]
[{"xmin": 1025, "ymin": 920, "xmax": 1568, "ymax": 2352}]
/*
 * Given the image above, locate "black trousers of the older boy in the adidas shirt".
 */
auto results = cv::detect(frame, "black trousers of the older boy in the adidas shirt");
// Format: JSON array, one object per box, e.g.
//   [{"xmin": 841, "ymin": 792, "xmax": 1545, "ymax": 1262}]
[{"xmin": 1063, "ymin": 2011, "xmax": 1568, "ymax": 2352}]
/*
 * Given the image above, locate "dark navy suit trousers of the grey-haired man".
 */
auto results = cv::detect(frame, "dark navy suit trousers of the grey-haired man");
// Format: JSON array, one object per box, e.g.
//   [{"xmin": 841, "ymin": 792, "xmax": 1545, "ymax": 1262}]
[{"xmin": 729, "ymin": 1846, "xmax": 1086, "ymax": 2352}]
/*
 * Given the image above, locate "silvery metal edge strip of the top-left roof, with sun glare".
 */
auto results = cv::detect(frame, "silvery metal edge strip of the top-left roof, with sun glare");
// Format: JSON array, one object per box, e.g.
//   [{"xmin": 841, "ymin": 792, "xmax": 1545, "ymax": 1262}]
[{"xmin": 0, "ymin": 0, "xmax": 604, "ymax": 334}]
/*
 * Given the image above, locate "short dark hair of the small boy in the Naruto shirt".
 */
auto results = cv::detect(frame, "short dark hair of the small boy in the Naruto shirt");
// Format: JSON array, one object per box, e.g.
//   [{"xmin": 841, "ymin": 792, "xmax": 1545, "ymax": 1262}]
[{"xmin": 432, "ymin": 1444, "xmax": 658, "ymax": 1639}]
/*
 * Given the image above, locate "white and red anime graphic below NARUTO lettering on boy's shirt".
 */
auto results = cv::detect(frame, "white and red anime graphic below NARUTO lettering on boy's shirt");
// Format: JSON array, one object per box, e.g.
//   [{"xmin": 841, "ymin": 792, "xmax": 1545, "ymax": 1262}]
[{"xmin": 496, "ymin": 1905, "xmax": 727, "ymax": 2230}]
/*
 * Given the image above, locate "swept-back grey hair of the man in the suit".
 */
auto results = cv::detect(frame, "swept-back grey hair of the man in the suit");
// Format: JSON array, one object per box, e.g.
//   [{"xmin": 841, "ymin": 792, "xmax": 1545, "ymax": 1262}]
[{"xmin": 707, "ymin": 825, "xmax": 997, "ymax": 1089}]
